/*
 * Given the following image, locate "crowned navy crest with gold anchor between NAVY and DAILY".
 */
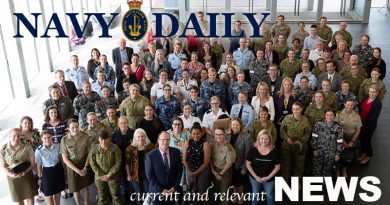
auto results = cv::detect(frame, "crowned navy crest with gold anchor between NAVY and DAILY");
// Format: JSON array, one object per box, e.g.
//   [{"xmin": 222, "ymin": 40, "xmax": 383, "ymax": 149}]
[{"xmin": 122, "ymin": 0, "xmax": 148, "ymax": 41}]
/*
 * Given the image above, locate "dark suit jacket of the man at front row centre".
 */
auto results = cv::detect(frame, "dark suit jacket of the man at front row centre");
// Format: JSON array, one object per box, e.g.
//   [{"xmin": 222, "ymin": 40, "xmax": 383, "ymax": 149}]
[{"xmin": 145, "ymin": 147, "xmax": 183, "ymax": 193}]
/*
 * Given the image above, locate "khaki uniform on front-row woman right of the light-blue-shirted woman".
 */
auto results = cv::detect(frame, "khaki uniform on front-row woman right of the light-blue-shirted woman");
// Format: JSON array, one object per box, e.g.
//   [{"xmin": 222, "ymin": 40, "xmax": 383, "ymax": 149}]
[{"xmin": 60, "ymin": 132, "xmax": 92, "ymax": 193}]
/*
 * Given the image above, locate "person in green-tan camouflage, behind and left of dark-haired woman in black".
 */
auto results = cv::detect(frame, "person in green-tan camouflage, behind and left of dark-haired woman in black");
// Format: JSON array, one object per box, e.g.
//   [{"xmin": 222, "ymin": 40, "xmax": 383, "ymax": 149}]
[{"xmin": 119, "ymin": 84, "xmax": 150, "ymax": 129}]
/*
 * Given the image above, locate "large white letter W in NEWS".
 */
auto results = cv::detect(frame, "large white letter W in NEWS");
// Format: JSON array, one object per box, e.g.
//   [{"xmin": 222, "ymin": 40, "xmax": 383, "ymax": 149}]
[{"xmin": 325, "ymin": 177, "xmax": 358, "ymax": 201}]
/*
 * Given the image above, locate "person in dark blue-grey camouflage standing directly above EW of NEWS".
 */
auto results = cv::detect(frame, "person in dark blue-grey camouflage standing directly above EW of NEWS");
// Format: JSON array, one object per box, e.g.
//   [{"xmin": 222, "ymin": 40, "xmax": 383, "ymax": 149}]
[{"xmin": 311, "ymin": 109, "xmax": 343, "ymax": 176}]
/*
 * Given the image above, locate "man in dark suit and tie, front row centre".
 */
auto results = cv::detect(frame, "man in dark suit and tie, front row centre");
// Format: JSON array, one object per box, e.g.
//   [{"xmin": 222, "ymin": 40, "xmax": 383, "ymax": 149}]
[{"xmin": 145, "ymin": 131, "xmax": 183, "ymax": 204}]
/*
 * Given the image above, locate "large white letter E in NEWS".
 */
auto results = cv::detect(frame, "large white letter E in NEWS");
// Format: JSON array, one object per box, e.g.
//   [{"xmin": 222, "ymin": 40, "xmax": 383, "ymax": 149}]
[{"xmin": 302, "ymin": 177, "xmax": 324, "ymax": 201}]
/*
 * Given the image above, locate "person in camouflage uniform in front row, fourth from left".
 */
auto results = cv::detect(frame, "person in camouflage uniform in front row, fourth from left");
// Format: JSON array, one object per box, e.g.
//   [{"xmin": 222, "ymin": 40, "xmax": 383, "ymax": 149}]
[{"xmin": 89, "ymin": 130, "xmax": 122, "ymax": 205}]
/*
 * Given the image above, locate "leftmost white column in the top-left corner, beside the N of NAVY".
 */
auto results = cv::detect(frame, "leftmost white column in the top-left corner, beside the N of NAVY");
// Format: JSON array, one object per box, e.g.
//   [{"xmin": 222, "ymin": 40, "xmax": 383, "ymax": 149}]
[{"xmin": 0, "ymin": 1, "xmax": 30, "ymax": 99}]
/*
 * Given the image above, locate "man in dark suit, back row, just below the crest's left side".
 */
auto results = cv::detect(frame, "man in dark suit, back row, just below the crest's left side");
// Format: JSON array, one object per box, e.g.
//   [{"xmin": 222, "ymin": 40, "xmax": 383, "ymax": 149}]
[{"xmin": 112, "ymin": 38, "xmax": 134, "ymax": 76}]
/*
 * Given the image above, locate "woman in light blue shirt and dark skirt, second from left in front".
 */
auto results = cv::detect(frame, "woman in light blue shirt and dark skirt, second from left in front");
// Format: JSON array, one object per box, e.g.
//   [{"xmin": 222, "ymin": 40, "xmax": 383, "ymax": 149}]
[{"xmin": 35, "ymin": 130, "xmax": 65, "ymax": 204}]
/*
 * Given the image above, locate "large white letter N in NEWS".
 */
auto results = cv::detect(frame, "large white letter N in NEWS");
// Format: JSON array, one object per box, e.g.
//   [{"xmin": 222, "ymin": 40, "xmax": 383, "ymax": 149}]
[{"xmin": 275, "ymin": 177, "xmax": 299, "ymax": 201}]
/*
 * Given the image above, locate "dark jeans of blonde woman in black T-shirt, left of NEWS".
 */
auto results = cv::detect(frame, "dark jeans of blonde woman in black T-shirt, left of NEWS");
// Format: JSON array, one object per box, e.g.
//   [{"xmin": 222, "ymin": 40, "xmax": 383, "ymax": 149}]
[{"xmin": 249, "ymin": 175, "xmax": 275, "ymax": 205}]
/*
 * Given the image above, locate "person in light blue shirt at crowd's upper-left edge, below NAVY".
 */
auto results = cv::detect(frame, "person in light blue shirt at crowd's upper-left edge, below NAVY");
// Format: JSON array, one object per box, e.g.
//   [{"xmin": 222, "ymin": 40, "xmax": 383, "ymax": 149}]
[{"xmin": 65, "ymin": 55, "xmax": 89, "ymax": 93}]
